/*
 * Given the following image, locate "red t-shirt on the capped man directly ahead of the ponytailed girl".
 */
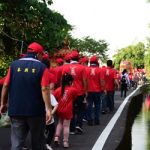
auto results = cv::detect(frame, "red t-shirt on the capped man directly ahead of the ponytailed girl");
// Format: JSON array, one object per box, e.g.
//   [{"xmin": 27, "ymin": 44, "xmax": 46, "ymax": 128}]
[{"xmin": 62, "ymin": 63, "xmax": 85, "ymax": 96}]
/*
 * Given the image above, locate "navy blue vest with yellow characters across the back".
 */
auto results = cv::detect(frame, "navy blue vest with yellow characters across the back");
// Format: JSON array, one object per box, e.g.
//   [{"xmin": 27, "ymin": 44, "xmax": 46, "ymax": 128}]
[{"xmin": 8, "ymin": 55, "xmax": 46, "ymax": 117}]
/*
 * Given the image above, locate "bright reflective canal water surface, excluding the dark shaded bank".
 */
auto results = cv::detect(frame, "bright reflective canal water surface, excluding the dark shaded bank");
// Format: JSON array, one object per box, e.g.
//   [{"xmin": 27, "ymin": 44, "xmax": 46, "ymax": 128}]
[{"xmin": 131, "ymin": 95, "xmax": 150, "ymax": 150}]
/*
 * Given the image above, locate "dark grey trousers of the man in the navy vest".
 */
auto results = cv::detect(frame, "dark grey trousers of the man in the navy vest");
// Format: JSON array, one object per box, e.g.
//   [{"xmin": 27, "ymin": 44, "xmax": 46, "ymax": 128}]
[{"xmin": 10, "ymin": 117, "xmax": 46, "ymax": 150}]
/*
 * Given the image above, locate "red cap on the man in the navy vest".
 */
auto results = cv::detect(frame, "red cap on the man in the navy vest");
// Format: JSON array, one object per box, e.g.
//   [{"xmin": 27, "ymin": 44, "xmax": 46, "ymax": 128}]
[{"xmin": 27, "ymin": 42, "xmax": 44, "ymax": 53}]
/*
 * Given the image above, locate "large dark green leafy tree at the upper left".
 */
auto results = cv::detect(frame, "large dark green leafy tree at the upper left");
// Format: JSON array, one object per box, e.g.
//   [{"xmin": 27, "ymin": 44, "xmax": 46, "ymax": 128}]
[{"xmin": 0, "ymin": 0, "xmax": 72, "ymax": 55}]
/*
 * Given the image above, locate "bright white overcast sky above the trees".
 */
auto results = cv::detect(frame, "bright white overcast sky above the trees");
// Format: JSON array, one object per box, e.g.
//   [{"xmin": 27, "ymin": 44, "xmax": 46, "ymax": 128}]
[{"xmin": 50, "ymin": 0, "xmax": 150, "ymax": 56}]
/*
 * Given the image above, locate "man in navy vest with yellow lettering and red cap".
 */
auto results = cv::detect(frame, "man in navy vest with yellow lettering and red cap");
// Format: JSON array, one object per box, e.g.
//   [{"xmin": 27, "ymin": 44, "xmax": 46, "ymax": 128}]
[{"xmin": 0, "ymin": 42, "xmax": 51, "ymax": 150}]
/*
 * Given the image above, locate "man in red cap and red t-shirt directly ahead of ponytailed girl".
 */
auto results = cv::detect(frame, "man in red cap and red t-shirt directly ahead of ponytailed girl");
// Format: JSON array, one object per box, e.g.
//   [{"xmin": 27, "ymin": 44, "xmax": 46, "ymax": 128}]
[{"xmin": 63, "ymin": 51, "xmax": 86, "ymax": 133}]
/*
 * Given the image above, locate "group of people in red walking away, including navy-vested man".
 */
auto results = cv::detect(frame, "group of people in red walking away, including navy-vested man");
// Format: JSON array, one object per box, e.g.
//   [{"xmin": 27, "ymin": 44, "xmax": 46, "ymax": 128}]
[{"xmin": 0, "ymin": 42, "xmax": 132, "ymax": 150}]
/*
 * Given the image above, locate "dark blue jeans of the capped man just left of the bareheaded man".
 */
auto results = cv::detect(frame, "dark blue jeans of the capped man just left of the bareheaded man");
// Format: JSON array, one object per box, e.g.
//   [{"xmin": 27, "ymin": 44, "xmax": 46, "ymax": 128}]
[{"xmin": 87, "ymin": 92, "xmax": 101, "ymax": 121}]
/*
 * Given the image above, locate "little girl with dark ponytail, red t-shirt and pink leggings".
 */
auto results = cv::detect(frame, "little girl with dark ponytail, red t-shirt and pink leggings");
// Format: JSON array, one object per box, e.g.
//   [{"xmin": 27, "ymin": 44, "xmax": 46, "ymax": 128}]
[{"xmin": 53, "ymin": 73, "xmax": 77, "ymax": 148}]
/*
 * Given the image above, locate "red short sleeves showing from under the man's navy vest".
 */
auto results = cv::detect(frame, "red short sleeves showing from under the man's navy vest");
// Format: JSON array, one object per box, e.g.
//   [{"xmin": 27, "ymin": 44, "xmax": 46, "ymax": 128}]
[{"xmin": 4, "ymin": 68, "xmax": 50, "ymax": 86}]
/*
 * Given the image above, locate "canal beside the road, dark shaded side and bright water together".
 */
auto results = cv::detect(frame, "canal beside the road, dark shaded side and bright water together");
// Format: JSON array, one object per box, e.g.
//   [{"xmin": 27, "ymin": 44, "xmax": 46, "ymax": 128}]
[{"xmin": 116, "ymin": 86, "xmax": 150, "ymax": 150}]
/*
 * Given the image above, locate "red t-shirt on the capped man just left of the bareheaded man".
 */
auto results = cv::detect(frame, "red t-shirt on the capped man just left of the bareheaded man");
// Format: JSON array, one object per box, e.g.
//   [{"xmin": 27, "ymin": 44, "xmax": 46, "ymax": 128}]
[{"xmin": 86, "ymin": 66, "xmax": 104, "ymax": 92}]
